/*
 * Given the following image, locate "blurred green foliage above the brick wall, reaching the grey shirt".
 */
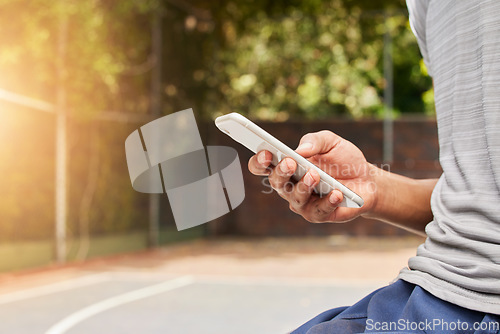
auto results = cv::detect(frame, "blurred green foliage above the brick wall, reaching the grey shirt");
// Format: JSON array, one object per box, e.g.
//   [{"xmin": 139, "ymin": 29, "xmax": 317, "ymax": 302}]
[{"xmin": 165, "ymin": 0, "xmax": 431, "ymax": 120}]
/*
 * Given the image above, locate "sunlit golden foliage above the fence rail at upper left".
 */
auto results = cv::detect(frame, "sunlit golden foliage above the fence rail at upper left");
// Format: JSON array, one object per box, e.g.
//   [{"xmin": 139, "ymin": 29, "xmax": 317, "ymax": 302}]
[{"xmin": 0, "ymin": 0, "xmax": 157, "ymax": 118}]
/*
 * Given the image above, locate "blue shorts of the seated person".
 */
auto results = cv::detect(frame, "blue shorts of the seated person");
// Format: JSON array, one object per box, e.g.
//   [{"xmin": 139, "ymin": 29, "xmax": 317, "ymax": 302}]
[{"xmin": 292, "ymin": 280, "xmax": 500, "ymax": 334}]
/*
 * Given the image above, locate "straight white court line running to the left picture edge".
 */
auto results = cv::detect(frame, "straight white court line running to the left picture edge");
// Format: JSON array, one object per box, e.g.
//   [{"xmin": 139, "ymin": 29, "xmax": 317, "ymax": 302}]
[{"xmin": 0, "ymin": 273, "xmax": 110, "ymax": 305}]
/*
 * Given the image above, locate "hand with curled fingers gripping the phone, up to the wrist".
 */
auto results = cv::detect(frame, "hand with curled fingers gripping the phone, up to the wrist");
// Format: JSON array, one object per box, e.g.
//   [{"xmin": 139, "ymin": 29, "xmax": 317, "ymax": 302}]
[{"xmin": 248, "ymin": 131, "xmax": 376, "ymax": 222}]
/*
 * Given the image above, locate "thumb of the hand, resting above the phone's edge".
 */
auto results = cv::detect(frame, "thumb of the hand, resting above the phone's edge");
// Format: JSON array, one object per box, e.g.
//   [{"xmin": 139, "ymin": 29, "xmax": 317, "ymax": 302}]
[{"xmin": 295, "ymin": 130, "xmax": 342, "ymax": 158}]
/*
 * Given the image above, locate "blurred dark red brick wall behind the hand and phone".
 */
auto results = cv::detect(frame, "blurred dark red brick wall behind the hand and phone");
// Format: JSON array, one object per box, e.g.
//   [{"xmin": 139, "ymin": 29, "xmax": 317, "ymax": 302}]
[{"xmin": 202, "ymin": 119, "xmax": 441, "ymax": 236}]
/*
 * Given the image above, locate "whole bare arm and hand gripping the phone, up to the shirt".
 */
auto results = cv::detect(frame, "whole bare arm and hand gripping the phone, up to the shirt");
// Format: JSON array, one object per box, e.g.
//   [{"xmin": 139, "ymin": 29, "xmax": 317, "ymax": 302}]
[{"xmin": 248, "ymin": 131, "xmax": 437, "ymax": 235}]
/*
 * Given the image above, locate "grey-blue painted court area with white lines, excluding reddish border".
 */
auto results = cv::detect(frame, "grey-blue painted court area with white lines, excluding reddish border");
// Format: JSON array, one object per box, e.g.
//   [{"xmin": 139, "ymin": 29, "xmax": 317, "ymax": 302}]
[{"xmin": 0, "ymin": 271, "xmax": 379, "ymax": 334}]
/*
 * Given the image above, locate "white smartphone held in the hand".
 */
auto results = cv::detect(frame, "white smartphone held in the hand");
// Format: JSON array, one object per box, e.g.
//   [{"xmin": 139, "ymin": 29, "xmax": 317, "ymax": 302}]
[{"xmin": 215, "ymin": 113, "xmax": 364, "ymax": 208}]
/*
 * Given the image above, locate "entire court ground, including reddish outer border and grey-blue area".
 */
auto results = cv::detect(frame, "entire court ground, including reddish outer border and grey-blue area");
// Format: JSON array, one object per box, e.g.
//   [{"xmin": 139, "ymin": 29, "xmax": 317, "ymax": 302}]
[{"xmin": 0, "ymin": 237, "xmax": 421, "ymax": 334}]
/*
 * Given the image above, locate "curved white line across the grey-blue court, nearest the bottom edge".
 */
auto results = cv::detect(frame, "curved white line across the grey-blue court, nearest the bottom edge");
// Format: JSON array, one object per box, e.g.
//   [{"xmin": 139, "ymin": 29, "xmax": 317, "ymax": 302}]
[{"xmin": 45, "ymin": 276, "xmax": 194, "ymax": 334}]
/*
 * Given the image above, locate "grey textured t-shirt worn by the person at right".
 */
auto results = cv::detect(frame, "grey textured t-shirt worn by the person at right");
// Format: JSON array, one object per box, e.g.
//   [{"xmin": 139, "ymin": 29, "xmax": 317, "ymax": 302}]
[{"xmin": 399, "ymin": 0, "xmax": 500, "ymax": 314}]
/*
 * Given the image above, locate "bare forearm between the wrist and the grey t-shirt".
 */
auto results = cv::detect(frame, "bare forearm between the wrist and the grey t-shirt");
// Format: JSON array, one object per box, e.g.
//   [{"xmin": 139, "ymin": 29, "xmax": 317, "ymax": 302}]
[{"xmin": 363, "ymin": 166, "xmax": 438, "ymax": 235}]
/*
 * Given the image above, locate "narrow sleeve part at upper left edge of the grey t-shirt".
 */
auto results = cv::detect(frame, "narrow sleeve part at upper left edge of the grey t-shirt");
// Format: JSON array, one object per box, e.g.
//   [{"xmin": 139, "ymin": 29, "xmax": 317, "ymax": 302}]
[{"xmin": 406, "ymin": 0, "xmax": 432, "ymax": 76}]
